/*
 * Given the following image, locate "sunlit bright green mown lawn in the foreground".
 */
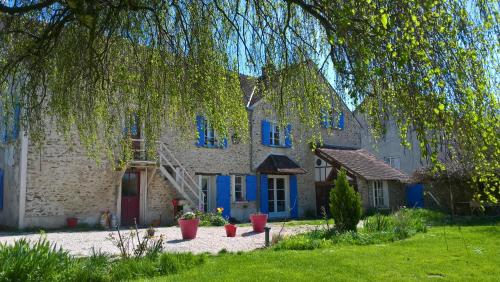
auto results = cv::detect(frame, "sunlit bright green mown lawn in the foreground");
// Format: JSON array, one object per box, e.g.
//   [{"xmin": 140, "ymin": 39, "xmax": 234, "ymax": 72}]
[{"xmin": 146, "ymin": 223, "xmax": 500, "ymax": 281}]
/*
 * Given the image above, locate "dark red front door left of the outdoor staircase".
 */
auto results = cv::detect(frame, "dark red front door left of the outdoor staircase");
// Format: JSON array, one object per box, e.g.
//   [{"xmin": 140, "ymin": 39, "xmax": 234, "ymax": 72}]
[{"xmin": 121, "ymin": 170, "xmax": 140, "ymax": 225}]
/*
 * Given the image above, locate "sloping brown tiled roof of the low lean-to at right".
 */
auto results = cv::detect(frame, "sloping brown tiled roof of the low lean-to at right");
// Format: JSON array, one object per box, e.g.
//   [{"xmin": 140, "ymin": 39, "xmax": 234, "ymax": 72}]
[{"xmin": 316, "ymin": 148, "xmax": 409, "ymax": 182}]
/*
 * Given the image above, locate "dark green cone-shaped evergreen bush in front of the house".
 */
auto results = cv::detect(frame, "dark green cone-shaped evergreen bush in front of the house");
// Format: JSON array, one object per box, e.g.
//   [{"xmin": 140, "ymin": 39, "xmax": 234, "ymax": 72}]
[{"xmin": 330, "ymin": 168, "xmax": 361, "ymax": 232}]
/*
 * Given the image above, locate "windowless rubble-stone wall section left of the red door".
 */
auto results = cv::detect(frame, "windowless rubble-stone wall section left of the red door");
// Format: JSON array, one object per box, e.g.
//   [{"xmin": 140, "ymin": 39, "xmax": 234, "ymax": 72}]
[{"xmin": 25, "ymin": 132, "xmax": 119, "ymax": 228}]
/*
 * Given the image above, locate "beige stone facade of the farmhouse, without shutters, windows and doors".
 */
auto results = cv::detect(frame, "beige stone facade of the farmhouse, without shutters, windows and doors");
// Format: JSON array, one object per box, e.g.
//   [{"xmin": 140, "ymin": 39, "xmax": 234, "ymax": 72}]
[{"xmin": 0, "ymin": 71, "xmax": 410, "ymax": 228}]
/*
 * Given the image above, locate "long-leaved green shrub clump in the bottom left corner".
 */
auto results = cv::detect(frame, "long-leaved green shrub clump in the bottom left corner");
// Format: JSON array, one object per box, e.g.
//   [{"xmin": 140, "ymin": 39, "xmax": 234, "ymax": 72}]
[{"xmin": 0, "ymin": 237, "xmax": 72, "ymax": 281}]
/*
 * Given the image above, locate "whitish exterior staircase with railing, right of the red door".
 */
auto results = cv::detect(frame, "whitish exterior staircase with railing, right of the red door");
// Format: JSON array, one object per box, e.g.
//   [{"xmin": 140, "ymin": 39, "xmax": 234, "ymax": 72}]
[{"xmin": 158, "ymin": 142, "xmax": 205, "ymax": 211}]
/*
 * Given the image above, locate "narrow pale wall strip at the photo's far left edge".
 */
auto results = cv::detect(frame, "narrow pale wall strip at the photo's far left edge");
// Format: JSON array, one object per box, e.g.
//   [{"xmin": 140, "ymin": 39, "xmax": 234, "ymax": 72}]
[{"xmin": 0, "ymin": 142, "xmax": 21, "ymax": 228}]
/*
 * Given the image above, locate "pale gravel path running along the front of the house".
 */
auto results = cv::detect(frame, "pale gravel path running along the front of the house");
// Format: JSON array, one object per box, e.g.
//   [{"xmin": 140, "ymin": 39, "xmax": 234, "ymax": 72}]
[{"xmin": 0, "ymin": 224, "xmax": 314, "ymax": 256}]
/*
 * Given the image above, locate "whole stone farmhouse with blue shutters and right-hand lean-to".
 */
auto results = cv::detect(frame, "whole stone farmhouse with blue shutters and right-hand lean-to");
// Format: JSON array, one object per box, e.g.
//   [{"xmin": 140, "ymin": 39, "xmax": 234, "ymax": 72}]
[{"xmin": 0, "ymin": 72, "xmax": 408, "ymax": 228}]
